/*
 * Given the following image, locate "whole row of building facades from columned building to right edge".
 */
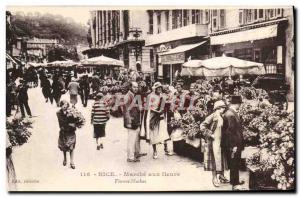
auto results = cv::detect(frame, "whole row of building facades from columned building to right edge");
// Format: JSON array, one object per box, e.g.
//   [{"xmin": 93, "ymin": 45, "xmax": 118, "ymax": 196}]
[{"xmin": 87, "ymin": 7, "xmax": 295, "ymax": 100}]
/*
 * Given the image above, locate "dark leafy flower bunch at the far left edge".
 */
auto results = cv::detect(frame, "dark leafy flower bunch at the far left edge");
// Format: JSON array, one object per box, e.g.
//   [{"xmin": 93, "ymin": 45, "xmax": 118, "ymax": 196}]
[{"xmin": 6, "ymin": 118, "xmax": 32, "ymax": 146}]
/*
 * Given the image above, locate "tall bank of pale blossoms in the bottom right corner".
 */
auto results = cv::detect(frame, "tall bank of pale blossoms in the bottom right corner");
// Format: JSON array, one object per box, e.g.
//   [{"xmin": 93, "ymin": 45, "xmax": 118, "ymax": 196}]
[{"xmin": 247, "ymin": 107, "xmax": 295, "ymax": 190}]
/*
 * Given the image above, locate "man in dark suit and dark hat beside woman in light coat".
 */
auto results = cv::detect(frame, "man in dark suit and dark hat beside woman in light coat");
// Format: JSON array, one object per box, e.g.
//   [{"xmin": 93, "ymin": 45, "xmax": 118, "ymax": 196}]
[{"xmin": 221, "ymin": 96, "xmax": 244, "ymax": 190}]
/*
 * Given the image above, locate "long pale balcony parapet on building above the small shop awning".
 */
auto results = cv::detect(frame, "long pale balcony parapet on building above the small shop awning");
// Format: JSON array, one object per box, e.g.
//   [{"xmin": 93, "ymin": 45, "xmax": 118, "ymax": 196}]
[{"xmin": 145, "ymin": 24, "xmax": 208, "ymax": 46}]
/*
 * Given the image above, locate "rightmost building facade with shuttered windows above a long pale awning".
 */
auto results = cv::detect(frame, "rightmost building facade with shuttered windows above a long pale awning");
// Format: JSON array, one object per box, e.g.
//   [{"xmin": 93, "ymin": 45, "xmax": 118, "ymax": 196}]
[{"xmin": 209, "ymin": 8, "xmax": 294, "ymax": 100}]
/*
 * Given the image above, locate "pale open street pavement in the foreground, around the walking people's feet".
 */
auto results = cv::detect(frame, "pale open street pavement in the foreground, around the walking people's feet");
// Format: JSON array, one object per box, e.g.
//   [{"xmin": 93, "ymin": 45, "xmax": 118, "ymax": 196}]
[{"xmin": 9, "ymin": 88, "xmax": 247, "ymax": 191}]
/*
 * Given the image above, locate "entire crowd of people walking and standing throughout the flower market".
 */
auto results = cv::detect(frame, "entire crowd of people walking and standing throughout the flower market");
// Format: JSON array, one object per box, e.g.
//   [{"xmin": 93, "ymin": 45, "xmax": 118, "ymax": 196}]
[{"xmin": 7, "ymin": 65, "xmax": 244, "ymax": 188}]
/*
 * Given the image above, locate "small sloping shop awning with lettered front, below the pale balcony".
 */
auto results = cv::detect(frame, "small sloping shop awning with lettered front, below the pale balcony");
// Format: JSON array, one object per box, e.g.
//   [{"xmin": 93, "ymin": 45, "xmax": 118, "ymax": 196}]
[{"xmin": 161, "ymin": 41, "xmax": 206, "ymax": 64}]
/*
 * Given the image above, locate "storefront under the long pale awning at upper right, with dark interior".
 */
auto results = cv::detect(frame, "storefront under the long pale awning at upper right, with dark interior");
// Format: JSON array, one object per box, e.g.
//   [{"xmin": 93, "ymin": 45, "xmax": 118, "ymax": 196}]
[{"xmin": 211, "ymin": 19, "xmax": 287, "ymax": 74}]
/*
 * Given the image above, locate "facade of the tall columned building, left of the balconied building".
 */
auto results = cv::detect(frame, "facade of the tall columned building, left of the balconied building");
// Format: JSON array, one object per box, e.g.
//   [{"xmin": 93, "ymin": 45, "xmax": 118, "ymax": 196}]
[{"xmin": 84, "ymin": 10, "xmax": 152, "ymax": 72}]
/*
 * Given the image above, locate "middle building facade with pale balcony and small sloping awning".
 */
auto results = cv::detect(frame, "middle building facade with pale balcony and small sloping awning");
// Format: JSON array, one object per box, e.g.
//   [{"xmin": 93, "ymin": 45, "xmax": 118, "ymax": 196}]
[{"xmin": 146, "ymin": 9, "xmax": 210, "ymax": 83}]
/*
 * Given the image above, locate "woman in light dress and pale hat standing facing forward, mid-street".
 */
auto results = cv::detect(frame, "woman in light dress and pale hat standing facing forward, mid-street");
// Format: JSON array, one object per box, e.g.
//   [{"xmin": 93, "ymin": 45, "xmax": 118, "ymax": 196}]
[{"xmin": 147, "ymin": 82, "xmax": 169, "ymax": 159}]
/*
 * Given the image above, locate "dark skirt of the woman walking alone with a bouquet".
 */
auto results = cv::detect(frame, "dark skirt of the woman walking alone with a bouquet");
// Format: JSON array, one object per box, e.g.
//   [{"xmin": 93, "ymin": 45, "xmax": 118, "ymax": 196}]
[{"xmin": 58, "ymin": 131, "xmax": 76, "ymax": 152}]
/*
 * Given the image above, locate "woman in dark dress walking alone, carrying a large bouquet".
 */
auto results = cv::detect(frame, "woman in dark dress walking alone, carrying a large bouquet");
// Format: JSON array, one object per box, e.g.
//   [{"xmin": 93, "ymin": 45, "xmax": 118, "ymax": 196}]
[{"xmin": 57, "ymin": 100, "xmax": 76, "ymax": 169}]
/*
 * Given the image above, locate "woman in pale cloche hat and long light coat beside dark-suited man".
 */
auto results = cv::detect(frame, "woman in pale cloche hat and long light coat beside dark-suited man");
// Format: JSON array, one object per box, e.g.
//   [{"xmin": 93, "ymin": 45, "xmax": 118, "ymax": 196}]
[{"xmin": 200, "ymin": 100, "xmax": 229, "ymax": 187}]
